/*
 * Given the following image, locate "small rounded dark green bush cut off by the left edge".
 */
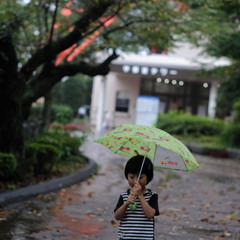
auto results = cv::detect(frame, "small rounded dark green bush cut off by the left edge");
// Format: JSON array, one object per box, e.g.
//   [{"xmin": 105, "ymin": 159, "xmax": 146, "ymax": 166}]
[{"xmin": 0, "ymin": 152, "xmax": 18, "ymax": 180}]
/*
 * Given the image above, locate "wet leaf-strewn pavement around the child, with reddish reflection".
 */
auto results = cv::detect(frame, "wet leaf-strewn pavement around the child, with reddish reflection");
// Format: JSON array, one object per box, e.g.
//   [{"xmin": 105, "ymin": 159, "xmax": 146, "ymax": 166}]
[{"xmin": 0, "ymin": 134, "xmax": 240, "ymax": 240}]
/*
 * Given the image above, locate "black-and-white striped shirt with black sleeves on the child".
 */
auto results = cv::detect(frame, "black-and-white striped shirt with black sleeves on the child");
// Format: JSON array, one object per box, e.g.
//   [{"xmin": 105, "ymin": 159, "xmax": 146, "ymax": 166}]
[{"xmin": 114, "ymin": 189, "xmax": 159, "ymax": 240}]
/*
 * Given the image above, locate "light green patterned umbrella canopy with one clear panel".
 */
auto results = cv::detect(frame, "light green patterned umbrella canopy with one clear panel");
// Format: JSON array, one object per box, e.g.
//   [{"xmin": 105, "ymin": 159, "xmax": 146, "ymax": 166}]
[{"xmin": 95, "ymin": 124, "xmax": 200, "ymax": 171}]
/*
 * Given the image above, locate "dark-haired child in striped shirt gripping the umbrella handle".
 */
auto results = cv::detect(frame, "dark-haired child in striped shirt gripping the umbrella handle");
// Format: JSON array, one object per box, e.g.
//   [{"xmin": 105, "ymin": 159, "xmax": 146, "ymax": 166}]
[{"xmin": 114, "ymin": 155, "xmax": 159, "ymax": 240}]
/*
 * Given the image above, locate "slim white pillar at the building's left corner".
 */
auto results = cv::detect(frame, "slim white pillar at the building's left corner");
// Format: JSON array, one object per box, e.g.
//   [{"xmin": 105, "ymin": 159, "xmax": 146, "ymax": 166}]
[{"xmin": 96, "ymin": 76, "xmax": 106, "ymax": 136}]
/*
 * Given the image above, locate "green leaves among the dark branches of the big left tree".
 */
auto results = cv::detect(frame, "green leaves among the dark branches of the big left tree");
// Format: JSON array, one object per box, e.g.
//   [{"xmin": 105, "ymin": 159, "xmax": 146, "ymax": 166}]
[{"xmin": 0, "ymin": 0, "xmax": 185, "ymax": 69}]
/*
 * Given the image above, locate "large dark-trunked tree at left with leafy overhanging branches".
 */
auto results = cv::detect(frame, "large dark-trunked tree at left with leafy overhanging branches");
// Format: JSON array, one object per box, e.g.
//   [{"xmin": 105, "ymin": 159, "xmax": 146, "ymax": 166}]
[{"xmin": 0, "ymin": 0, "xmax": 188, "ymax": 158}]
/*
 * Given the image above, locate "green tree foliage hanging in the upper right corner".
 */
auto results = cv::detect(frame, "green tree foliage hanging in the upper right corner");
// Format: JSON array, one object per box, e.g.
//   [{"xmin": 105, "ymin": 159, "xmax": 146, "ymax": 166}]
[{"xmin": 179, "ymin": 0, "xmax": 240, "ymax": 117}]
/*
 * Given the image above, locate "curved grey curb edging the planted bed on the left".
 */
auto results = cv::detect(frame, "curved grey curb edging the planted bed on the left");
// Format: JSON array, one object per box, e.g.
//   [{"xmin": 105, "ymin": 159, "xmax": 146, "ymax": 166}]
[{"xmin": 0, "ymin": 158, "xmax": 97, "ymax": 208}]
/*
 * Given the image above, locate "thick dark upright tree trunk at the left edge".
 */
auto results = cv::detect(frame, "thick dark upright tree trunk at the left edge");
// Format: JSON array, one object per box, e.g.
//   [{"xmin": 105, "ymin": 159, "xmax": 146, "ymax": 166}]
[{"xmin": 0, "ymin": 35, "xmax": 25, "ymax": 176}]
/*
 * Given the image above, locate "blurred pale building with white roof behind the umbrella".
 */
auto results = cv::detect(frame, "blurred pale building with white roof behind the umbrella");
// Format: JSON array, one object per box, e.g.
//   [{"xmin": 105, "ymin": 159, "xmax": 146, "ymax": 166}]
[{"xmin": 91, "ymin": 45, "xmax": 231, "ymax": 131}]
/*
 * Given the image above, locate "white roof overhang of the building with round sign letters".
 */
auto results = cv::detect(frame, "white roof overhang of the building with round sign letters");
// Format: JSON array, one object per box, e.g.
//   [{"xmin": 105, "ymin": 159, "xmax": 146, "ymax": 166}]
[{"xmin": 108, "ymin": 43, "xmax": 230, "ymax": 81}]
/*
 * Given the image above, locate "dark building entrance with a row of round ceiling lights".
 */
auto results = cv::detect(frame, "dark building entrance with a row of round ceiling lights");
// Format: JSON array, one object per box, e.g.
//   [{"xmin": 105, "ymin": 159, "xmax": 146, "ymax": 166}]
[{"xmin": 140, "ymin": 78, "xmax": 209, "ymax": 116}]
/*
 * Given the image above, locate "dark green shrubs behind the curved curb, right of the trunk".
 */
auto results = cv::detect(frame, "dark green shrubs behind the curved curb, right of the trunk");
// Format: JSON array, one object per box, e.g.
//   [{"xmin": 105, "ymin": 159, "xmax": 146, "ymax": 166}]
[{"xmin": 25, "ymin": 128, "xmax": 84, "ymax": 175}]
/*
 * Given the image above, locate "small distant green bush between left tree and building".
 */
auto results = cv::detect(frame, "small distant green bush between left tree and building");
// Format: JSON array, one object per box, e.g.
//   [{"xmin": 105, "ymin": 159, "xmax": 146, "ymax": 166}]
[{"xmin": 52, "ymin": 104, "xmax": 73, "ymax": 123}]
